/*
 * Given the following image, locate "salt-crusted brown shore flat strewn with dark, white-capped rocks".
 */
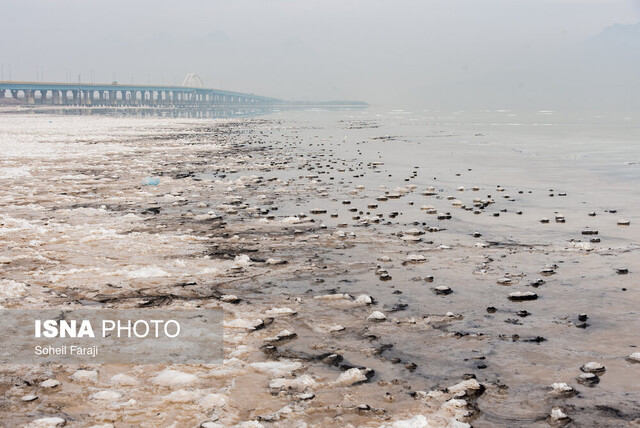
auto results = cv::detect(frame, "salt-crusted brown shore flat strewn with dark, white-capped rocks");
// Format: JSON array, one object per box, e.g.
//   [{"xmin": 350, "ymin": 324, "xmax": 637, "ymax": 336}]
[{"xmin": 0, "ymin": 112, "xmax": 640, "ymax": 427}]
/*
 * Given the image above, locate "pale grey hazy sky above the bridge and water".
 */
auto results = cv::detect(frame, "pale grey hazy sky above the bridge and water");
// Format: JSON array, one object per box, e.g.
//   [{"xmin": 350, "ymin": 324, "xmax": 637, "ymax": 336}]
[{"xmin": 0, "ymin": 0, "xmax": 640, "ymax": 108}]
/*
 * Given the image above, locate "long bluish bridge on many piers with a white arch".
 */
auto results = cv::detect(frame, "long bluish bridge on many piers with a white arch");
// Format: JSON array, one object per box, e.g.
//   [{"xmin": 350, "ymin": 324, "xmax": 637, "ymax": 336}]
[{"xmin": 0, "ymin": 73, "xmax": 282, "ymax": 108}]
